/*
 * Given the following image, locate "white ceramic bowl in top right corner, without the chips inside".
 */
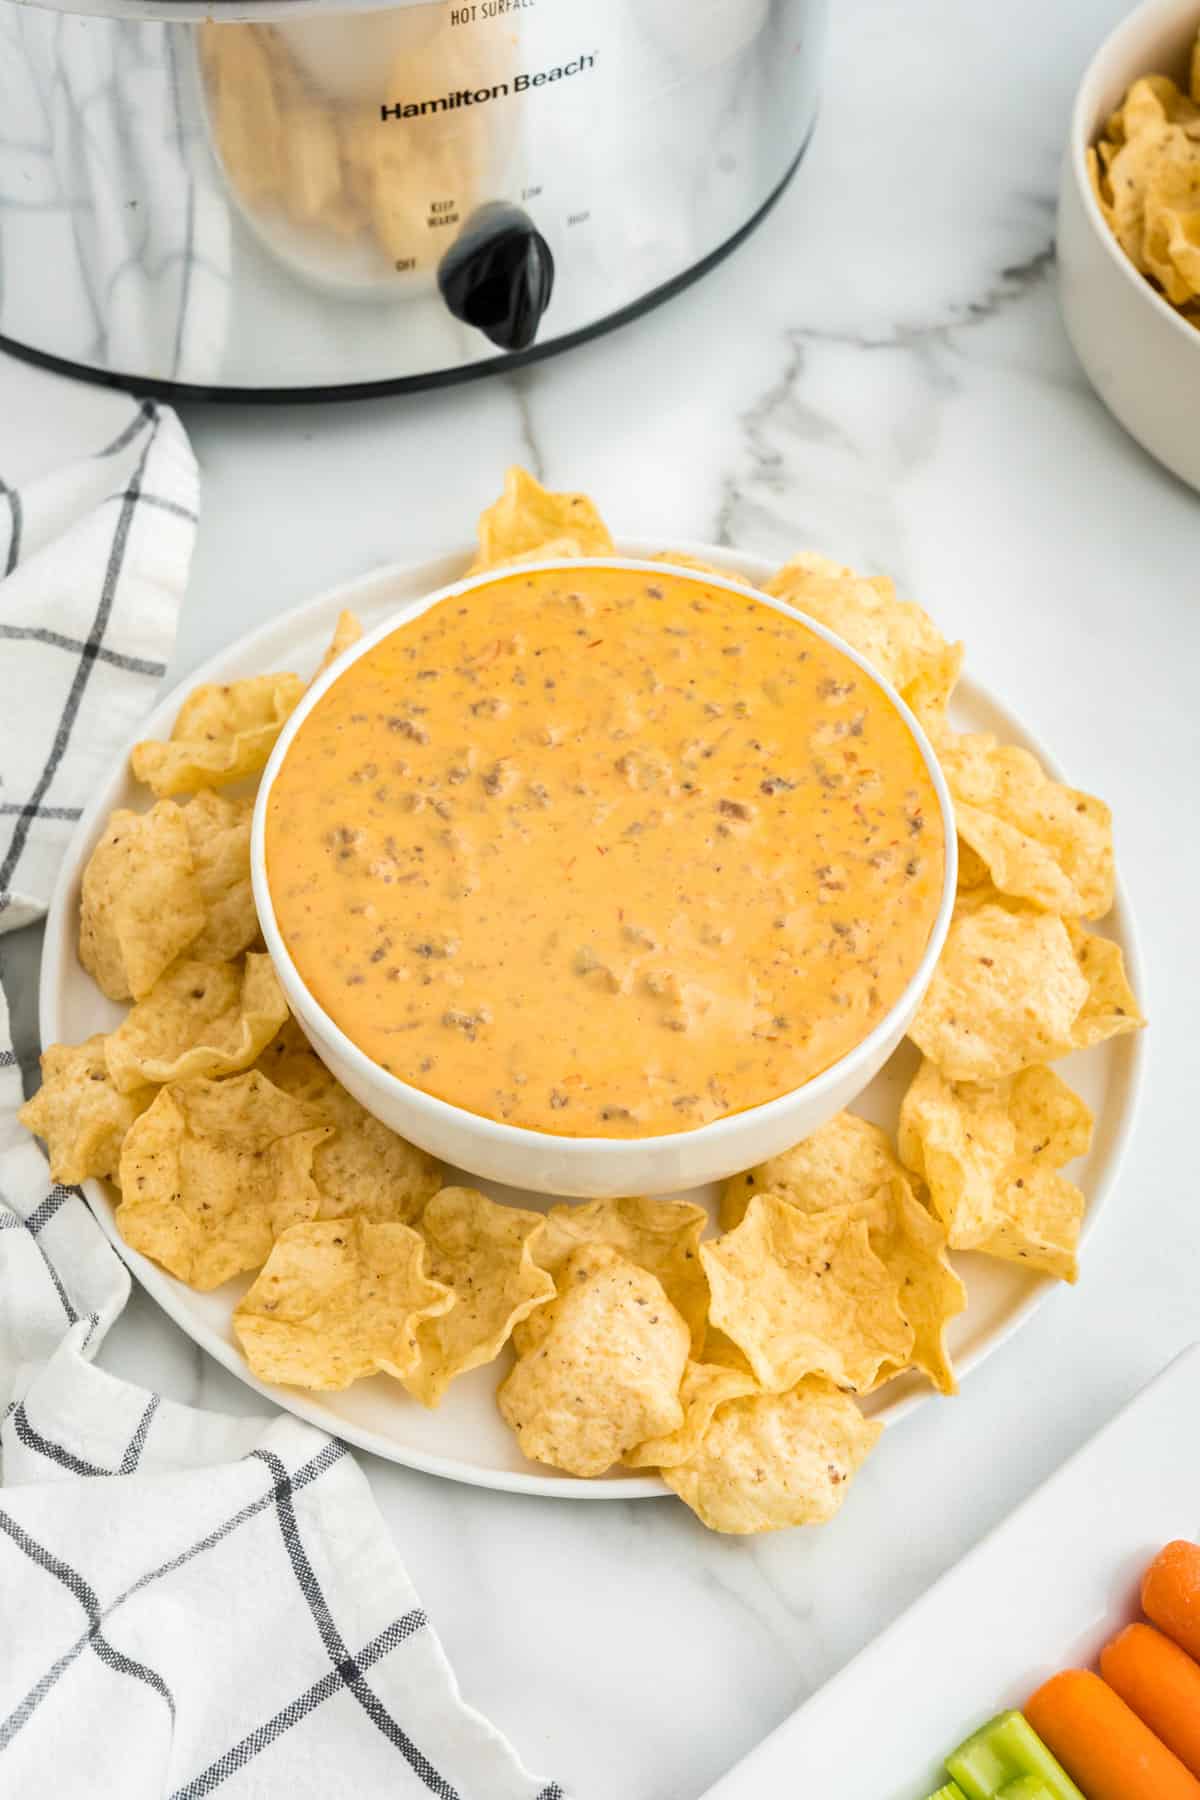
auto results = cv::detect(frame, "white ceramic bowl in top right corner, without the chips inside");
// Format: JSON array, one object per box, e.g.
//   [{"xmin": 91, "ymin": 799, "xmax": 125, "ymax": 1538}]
[{"xmin": 1058, "ymin": 0, "xmax": 1200, "ymax": 488}]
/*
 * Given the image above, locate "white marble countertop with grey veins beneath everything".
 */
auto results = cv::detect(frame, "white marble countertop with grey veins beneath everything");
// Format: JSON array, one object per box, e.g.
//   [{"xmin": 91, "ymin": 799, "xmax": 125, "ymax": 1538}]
[{"xmin": 0, "ymin": 0, "xmax": 1200, "ymax": 1800}]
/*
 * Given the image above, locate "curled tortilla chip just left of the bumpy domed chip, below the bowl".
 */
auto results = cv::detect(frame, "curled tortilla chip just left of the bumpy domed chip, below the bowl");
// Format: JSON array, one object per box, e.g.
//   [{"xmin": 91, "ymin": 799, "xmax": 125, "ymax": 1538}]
[{"xmin": 407, "ymin": 1188, "xmax": 554, "ymax": 1406}]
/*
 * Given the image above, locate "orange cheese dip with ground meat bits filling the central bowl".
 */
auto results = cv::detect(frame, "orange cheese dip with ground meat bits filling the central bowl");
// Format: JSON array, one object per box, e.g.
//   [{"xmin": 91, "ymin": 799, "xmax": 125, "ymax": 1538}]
[{"xmin": 266, "ymin": 565, "xmax": 945, "ymax": 1138}]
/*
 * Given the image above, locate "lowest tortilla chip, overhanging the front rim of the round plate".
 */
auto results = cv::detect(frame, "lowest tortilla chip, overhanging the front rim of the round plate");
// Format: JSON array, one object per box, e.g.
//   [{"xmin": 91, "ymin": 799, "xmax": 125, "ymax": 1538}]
[{"xmin": 662, "ymin": 1375, "xmax": 883, "ymax": 1535}]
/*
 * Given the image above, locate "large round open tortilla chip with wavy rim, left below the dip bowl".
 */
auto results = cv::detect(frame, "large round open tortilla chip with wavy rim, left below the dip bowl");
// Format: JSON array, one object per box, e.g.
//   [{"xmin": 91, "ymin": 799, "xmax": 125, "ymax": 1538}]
[{"xmin": 117, "ymin": 1069, "xmax": 329, "ymax": 1291}]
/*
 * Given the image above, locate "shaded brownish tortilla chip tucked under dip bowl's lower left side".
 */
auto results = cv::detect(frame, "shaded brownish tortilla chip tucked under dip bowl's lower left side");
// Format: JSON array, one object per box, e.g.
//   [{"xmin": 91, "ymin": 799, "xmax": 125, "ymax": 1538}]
[{"xmin": 257, "ymin": 1021, "xmax": 443, "ymax": 1224}]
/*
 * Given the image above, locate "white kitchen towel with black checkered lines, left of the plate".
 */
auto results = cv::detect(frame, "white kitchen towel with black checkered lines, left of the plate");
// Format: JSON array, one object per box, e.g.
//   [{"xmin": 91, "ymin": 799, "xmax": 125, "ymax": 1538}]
[{"xmin": 0, "ymin": 394, "xmax": 561, "ymax": 1800}]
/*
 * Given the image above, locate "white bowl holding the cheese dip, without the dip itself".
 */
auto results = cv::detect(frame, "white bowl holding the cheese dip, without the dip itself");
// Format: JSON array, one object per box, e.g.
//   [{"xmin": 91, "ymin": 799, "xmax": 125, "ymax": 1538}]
[{"xmin": 250, "ymin": 556, "xmax": 957, "ymax": 1199}]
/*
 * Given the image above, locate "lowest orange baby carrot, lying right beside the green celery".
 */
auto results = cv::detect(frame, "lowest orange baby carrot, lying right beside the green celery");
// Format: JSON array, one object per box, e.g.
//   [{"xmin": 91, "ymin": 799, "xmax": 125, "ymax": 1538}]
[{"xmin": 1024, "ymin": 1669, "xmax": 1200, "ymax": 1800}]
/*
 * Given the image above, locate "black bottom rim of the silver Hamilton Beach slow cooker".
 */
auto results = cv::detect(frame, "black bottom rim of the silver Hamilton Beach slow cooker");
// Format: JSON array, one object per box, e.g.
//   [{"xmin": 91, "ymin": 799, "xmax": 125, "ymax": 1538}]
[{"xmin": 0, "ymin": 121, "xmax": 815, "ymax": 407}]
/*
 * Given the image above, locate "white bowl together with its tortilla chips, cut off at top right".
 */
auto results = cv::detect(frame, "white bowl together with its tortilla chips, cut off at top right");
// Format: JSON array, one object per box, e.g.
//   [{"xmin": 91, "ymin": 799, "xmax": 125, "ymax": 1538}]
[{"xmin": 1058, "ymin": 0, "xmax": 1200, "ymax": 488}]
